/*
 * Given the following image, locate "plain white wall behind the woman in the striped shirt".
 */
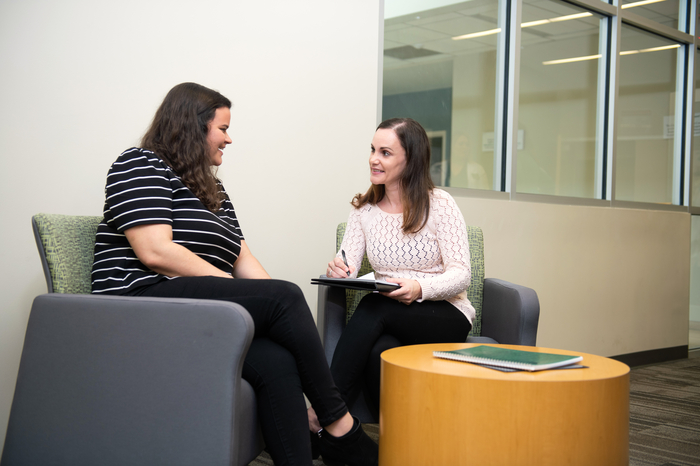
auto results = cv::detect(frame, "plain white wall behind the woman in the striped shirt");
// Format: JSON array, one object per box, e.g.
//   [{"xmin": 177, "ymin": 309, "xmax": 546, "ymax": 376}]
[{"xmin": 0, "ymin": 0, "xmax": 379, "ymax": 452}]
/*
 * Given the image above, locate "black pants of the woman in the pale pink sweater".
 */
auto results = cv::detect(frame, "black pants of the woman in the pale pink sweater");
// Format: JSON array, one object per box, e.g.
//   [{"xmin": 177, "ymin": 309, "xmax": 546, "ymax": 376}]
[{"xmin": 331, "ymin": 294, "xmax": 472, "ymax": 410}]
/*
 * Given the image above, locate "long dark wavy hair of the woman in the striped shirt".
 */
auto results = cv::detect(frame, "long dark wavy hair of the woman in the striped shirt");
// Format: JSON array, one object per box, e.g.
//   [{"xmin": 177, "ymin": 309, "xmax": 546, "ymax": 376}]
[{"xmin": 141, "ymin": 83, "xmax": 231, "ymax": 212}]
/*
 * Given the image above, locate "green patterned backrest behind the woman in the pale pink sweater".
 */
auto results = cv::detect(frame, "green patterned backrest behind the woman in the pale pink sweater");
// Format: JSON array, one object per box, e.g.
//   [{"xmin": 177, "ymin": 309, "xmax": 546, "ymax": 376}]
[{"xmin": 335, "ymin": 223, "xmax": 484, "ymax": 336}]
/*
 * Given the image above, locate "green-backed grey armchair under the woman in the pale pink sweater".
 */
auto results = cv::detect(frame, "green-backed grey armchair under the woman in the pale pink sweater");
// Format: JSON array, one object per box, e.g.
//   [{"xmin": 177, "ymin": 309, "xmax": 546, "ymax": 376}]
[{"xmin": 317, "ymin": 223, "xmax": 540, "ymax": 422}]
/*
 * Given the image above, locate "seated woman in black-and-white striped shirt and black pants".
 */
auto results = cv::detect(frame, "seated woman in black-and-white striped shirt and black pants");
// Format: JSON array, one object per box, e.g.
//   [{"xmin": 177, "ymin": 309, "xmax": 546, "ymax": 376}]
[{"xmin": 92, "ymin": 83, "xmax": 378, "ymax": 466}]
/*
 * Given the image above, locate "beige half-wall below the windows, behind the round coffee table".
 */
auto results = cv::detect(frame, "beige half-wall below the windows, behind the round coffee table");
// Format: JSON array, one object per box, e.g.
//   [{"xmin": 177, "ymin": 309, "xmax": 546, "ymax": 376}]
[{"xmin": 457, "ymin": 197, "xmax": 690, "ymax": 356}]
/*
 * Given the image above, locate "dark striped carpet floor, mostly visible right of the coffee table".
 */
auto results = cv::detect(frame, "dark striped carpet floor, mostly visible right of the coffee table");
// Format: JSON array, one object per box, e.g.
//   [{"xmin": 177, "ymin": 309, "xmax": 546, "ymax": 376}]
[{"xmin": 250, "ymin": 351, "xmax": 700, "ymax": 466}]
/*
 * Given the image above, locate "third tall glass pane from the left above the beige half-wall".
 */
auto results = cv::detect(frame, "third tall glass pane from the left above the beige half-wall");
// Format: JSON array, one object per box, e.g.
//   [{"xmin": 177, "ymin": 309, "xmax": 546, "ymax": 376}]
[{"xmin": 615, "ymin": 24, "xmax": 678, "ymax": 204}]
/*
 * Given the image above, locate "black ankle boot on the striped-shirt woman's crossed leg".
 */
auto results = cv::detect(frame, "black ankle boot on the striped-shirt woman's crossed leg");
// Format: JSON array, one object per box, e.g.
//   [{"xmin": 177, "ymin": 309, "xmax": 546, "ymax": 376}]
[{"xmin": 318, "ymin": 416, "xmax": 379, "ymax": 466}]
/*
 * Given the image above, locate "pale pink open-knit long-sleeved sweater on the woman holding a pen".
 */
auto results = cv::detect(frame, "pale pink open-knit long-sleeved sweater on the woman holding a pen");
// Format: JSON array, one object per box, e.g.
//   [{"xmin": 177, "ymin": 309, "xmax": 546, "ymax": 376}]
[{"xmin": 338, "ymin": 188, "xmax": 475, "ymax": 322}]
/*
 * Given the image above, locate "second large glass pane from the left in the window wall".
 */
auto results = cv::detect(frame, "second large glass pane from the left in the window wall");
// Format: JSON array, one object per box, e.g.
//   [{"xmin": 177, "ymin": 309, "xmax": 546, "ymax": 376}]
[{"xmin": 517, "ymin": 0, "xmax": 602, "ymax": 198}]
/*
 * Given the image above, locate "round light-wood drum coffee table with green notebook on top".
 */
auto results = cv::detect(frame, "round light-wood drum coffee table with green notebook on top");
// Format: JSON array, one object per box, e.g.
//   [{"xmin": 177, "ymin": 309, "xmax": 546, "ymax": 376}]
[{"xmin": 379, "ymin": 343, "xmax": 629, "ymax": 466}]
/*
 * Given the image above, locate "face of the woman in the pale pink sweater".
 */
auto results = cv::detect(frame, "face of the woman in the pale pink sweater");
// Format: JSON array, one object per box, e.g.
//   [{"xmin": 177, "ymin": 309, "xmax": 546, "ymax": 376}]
[{"xmin": 369, "ymin": 129, "xmax": 406, "ymax": 188}]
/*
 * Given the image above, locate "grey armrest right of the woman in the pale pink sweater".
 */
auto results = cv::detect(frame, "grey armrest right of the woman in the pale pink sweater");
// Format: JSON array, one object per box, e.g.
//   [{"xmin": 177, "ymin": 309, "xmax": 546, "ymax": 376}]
[{"xmin": 481, "ymin": 278, "xmax": 540, "ymax": 346}]
